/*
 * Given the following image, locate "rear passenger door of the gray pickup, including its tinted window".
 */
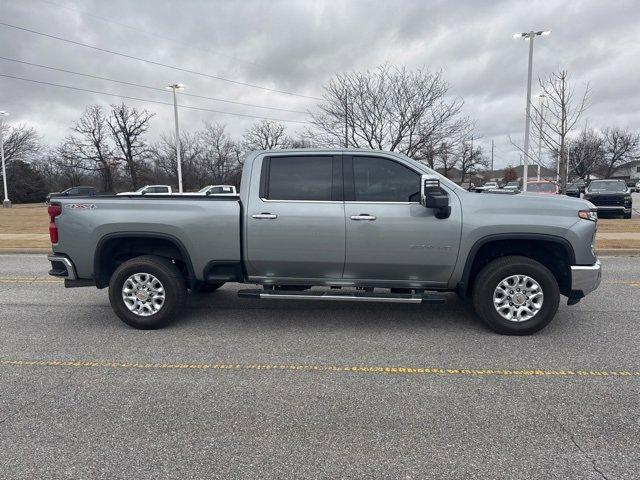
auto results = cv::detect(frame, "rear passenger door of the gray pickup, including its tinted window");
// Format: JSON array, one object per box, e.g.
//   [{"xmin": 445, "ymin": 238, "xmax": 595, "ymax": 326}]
[{"xmin": 245, "ymin": 154, "xmax": 345, "ymax": 281}]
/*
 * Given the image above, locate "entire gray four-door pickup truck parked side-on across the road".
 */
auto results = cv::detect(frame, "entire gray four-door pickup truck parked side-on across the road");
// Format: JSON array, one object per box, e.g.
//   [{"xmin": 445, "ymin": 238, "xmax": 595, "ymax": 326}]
[{"xmin": 48, "ymin": 149, "xmax": 601, "ymax": 335}]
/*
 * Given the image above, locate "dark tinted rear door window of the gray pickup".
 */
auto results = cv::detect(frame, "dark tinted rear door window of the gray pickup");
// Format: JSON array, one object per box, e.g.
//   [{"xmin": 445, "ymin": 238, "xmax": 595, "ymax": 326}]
[{"xmin": 267, "ymin": 157, "xmax": 333, "ymax": 200}]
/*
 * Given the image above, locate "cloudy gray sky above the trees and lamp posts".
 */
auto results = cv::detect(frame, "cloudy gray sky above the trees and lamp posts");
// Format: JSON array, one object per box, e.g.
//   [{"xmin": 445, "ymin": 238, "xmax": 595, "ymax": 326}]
[{"xmin": 0, "ymin": 0, "xmax": 640, "ymax": 166}]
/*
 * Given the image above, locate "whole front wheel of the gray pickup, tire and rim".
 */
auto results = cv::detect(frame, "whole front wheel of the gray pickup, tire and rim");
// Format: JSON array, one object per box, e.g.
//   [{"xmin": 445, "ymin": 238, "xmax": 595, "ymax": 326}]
[{"xmin": 473, "ymin": 256, "xmax": 560, "ymax": 335}]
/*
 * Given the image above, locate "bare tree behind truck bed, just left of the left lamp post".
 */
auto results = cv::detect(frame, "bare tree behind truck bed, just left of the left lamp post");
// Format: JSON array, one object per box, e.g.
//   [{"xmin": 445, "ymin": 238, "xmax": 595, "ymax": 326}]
[{"xmin": 107, "ymin": 103, "xmax": 155, "ymax": 189}]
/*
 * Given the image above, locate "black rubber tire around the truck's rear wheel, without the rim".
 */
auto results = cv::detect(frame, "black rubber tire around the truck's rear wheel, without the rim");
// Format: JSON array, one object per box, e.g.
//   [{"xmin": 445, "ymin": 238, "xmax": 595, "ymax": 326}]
[{"xmin": 109, "ymin": 255, "xmax": 187, "ymax": 330}]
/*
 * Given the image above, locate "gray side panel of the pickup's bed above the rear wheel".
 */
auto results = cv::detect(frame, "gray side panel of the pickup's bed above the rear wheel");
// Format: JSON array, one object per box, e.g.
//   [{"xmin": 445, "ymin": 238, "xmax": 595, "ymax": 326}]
[{"xmin": 51, "ymin": 195, "xmax": 241, "ymax": 280}]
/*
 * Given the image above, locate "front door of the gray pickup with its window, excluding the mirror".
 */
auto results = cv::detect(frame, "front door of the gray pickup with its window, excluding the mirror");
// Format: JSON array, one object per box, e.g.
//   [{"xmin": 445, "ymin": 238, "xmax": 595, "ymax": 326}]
[{"xmin": 343, "ymin": 155, "xmax": 461, "ymax": 286}]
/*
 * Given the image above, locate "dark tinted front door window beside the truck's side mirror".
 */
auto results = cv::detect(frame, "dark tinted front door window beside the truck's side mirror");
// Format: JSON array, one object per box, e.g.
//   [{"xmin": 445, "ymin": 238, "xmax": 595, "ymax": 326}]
[{"xmin": 353, "ymin": 157, "xmax": 420, "ymax": 202}]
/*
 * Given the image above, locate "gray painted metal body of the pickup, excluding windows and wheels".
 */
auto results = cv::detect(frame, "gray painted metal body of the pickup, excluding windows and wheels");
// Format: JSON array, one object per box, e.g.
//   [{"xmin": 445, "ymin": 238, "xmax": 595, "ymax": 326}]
[{"xmin": 53, "ymin": 149, "xmax": 597, "ymax": 298}]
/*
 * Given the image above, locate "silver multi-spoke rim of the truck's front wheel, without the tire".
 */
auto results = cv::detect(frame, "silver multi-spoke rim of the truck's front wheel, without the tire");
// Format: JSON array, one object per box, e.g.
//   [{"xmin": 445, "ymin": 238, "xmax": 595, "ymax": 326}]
[{"xmin": 493, "ymin": 275, "xmax": 544, "ymax": 322}]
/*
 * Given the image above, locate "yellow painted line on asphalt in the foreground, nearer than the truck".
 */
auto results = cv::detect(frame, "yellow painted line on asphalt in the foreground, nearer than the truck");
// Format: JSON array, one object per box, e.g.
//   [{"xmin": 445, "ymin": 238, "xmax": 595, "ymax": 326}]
[{"xmin": 0, "ymin": 360, "xmax": 640, "ymax": 378}]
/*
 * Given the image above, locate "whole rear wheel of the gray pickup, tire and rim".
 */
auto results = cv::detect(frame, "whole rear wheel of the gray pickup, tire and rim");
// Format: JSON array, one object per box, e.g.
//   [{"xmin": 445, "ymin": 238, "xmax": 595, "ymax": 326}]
[{"xmin": 109, "ymin": 255, "xmax": 187, "ymax": 330}]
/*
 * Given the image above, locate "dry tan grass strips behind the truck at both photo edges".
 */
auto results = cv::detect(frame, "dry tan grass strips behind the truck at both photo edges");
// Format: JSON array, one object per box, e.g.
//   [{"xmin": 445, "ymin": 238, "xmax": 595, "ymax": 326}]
[{"xmin": 0, "ymin": 204, "xmax": 640, "ymax": 252}]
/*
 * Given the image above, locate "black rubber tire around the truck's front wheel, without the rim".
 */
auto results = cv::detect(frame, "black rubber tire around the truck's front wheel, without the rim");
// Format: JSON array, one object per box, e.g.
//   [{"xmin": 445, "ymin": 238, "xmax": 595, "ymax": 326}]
[{"xmin": 473, "ymin": 255, "xmax": 560, "ymax": 335}]
